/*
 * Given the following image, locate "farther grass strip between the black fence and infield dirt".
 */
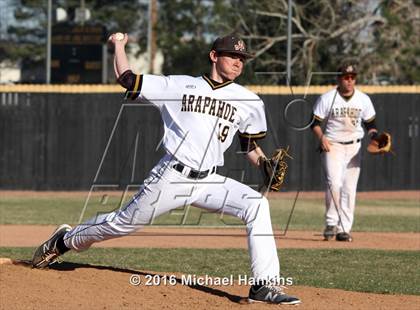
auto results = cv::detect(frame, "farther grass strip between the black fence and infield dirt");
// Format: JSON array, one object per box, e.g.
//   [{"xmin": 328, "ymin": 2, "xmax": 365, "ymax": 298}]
[{"xmin": 0, "ymin": 195, "xmax": 420, "ymax": 232}]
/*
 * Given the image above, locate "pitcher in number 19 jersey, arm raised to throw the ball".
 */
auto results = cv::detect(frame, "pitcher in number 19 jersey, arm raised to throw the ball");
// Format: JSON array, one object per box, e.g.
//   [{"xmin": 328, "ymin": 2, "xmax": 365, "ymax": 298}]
[{"xmin": 33, "ymin": 34, "xmax": 300, "ymax": 304}]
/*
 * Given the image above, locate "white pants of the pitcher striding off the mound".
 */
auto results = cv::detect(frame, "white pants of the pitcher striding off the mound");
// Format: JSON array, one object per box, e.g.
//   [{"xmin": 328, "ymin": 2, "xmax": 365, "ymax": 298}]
[{"xmin": 64, "ymin": 155, "xmax": 280, "ymax": 280}]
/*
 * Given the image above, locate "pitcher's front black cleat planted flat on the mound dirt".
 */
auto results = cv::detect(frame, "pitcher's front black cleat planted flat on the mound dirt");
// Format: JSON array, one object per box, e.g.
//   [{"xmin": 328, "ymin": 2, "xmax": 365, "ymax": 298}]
[{"xmin": 248, "ymin": 285, "xmax": 301, "ymax": 305}]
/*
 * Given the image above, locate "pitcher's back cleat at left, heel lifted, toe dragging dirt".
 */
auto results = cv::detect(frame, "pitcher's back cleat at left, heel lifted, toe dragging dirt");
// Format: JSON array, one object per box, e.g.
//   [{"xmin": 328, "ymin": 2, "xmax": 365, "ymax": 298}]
[{"xmin": 32, "ymin": 224, "xmax": 72, "ymax": 269}]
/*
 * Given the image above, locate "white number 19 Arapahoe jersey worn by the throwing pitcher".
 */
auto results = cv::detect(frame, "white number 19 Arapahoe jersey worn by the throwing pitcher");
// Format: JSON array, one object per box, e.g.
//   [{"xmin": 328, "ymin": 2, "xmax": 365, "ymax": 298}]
[{"xmin": 127, "ymin": 75, "xmax": 267, "ymax": 171}]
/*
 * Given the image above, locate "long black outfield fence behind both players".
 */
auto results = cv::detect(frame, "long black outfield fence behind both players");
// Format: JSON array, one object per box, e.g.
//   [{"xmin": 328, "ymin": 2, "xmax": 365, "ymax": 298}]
[{"xmin": 0, "ymin": 93, "xmax": 420, "ymax": 191}]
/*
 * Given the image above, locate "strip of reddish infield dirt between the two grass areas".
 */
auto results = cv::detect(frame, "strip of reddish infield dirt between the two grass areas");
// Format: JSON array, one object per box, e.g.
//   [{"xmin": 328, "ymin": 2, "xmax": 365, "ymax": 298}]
[{"xmin": 0, "ymin": 225, "xmax": 420, "ymax": 251}]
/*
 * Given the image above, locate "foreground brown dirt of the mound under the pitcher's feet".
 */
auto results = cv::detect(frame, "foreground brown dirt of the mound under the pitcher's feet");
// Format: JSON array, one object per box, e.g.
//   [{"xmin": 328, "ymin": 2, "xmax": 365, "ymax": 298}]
[{"xmin": 0, "ymin": 263, "xmax": 420, "ymax": 310}]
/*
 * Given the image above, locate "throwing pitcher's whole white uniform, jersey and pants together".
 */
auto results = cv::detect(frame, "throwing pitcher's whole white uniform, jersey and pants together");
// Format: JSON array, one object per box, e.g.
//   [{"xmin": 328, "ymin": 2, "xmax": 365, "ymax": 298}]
[{"xmin": 63, "ymin": 75, "xmax": 280, "ymax": 283}]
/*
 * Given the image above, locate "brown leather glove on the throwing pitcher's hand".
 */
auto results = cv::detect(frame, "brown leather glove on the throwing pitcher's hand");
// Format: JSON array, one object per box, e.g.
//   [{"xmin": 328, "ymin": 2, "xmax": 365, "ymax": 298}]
[{"xmin": 258, "ymin": 147, "xmax": 293, "ymax": 192}]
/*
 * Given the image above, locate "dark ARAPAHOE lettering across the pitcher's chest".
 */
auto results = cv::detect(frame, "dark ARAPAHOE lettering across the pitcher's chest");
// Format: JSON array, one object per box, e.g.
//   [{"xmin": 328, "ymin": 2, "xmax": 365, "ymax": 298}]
[{"xmin": 181, "ymin": 94, "xmax": 236, "ymax": 123}]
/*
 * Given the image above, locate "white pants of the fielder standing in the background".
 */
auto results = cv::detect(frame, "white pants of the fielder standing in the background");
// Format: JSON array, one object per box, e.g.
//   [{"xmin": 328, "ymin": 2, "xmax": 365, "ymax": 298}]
[{"xmin": 322, "ymin": 142, "xmax": 361, "ymax": 233}]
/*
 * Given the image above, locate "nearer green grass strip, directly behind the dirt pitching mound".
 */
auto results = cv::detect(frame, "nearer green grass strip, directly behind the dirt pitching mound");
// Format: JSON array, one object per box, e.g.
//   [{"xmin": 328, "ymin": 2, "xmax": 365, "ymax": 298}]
[{"xmin": 0, "ymin": 248, "xmax": 420, "ymax": 295}]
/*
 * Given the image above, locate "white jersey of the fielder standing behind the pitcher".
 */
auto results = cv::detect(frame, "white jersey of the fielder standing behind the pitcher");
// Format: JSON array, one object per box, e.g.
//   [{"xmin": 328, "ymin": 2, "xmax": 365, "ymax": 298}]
[{"xmin": 314, "ymin": 89, "xmax": 375, "ymax": 142}]
